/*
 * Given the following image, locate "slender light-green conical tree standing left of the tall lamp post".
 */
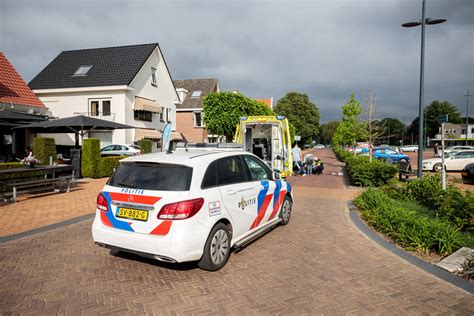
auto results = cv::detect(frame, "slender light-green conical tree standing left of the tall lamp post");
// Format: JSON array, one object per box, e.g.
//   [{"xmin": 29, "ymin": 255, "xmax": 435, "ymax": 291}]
[{"xmin": 333, "ymin": 93, "xmax": 366, "ymax": 145}]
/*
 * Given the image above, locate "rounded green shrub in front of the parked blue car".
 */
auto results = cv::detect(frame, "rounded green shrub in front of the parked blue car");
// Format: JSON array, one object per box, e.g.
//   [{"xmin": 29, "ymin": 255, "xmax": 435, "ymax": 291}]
[{"xmin": 346, "ymin": 156, "xmax": 398, "ymax": 187}]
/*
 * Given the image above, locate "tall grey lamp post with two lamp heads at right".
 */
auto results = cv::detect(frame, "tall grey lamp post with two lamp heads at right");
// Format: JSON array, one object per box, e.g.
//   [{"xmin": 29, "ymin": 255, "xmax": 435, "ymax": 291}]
[{"xmin": 402, "ymin": 0, "xmax": 446, "ymax": 178}]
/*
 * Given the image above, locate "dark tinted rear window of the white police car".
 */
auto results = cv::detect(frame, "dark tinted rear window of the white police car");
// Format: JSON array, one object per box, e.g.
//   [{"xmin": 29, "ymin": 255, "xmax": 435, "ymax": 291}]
[{"xmin": 107, "ymin": 162, "xmax": 193, "ymax": 191}]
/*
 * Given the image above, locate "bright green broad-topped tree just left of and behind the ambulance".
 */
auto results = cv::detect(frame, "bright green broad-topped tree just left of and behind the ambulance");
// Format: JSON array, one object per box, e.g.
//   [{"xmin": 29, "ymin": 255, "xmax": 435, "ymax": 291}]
[{"xmin": 203, "ymin": 92, "xmax": 275, "ymax": 140}]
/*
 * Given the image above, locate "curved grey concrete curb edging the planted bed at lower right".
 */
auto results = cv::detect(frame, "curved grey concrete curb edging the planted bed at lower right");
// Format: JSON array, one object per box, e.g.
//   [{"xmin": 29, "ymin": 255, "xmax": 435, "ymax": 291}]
[{"xmin": 349, "ymin": 206, "xmax": 474, "ymax": 294}]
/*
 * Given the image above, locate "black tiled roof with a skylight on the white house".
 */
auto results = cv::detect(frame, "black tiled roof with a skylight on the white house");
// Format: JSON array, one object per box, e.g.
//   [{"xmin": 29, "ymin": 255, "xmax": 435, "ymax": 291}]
[{"xmin": 29, "ymin": 43, "xmax": 158, "ymax": 90}]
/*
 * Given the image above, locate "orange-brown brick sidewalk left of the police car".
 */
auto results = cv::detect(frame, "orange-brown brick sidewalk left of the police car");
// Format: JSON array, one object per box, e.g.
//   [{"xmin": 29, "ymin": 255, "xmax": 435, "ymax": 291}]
[{"xmin": 0, "ymin": 178, "xmax": 108, "ymax": 237}]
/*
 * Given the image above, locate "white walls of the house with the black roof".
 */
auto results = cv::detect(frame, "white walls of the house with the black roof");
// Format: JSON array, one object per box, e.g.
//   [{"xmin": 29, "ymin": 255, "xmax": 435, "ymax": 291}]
[{"xmin": 34, "ymin": 48, "xmax": 179, "ymax": 145}]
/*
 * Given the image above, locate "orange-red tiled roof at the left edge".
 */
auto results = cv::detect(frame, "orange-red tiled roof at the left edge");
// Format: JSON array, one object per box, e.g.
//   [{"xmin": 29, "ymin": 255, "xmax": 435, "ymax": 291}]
[{"xmin": 0, "ymin": 52, "xmax": 45, "ymax": 108}]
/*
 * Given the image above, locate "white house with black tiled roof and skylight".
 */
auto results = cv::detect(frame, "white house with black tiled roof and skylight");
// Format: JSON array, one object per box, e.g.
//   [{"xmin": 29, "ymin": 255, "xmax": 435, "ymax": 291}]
[{"xmin": 29, "ymin": 43, "xmax": 181, "ymax": 151}]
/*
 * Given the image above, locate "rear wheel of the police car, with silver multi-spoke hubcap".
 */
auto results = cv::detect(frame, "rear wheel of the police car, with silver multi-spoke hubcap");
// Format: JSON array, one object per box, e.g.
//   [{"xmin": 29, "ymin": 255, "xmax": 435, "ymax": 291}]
[{"xmin": 198, "ymin": 223, "xmax": 230, "ymax": 271}]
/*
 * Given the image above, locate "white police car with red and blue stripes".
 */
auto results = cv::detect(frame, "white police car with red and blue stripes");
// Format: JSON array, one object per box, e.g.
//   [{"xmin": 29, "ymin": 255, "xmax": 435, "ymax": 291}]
[{"xmin": 92, "ymin": 148, "xmax": 293, "ymax": 271}]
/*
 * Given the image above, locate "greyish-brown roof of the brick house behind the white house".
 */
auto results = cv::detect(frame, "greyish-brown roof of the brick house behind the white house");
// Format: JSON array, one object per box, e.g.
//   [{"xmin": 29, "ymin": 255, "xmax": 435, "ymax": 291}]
[{"xmin": 173, "ymin": 78, "xmax": 218, "ymax": 110}]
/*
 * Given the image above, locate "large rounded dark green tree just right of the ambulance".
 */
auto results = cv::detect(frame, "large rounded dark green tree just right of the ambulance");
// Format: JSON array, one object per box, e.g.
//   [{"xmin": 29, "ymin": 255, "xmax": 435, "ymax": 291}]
[{"xmin": 274, "ymin": 92, "xmax": 319, "ymax": 143}]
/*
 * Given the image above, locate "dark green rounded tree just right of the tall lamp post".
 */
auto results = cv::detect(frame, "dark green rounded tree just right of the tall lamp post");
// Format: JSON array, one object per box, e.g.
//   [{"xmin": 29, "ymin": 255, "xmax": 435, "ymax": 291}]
[{"xmin": 425, "ymin": 100, "xmax": 461, "ymax": 138}]
